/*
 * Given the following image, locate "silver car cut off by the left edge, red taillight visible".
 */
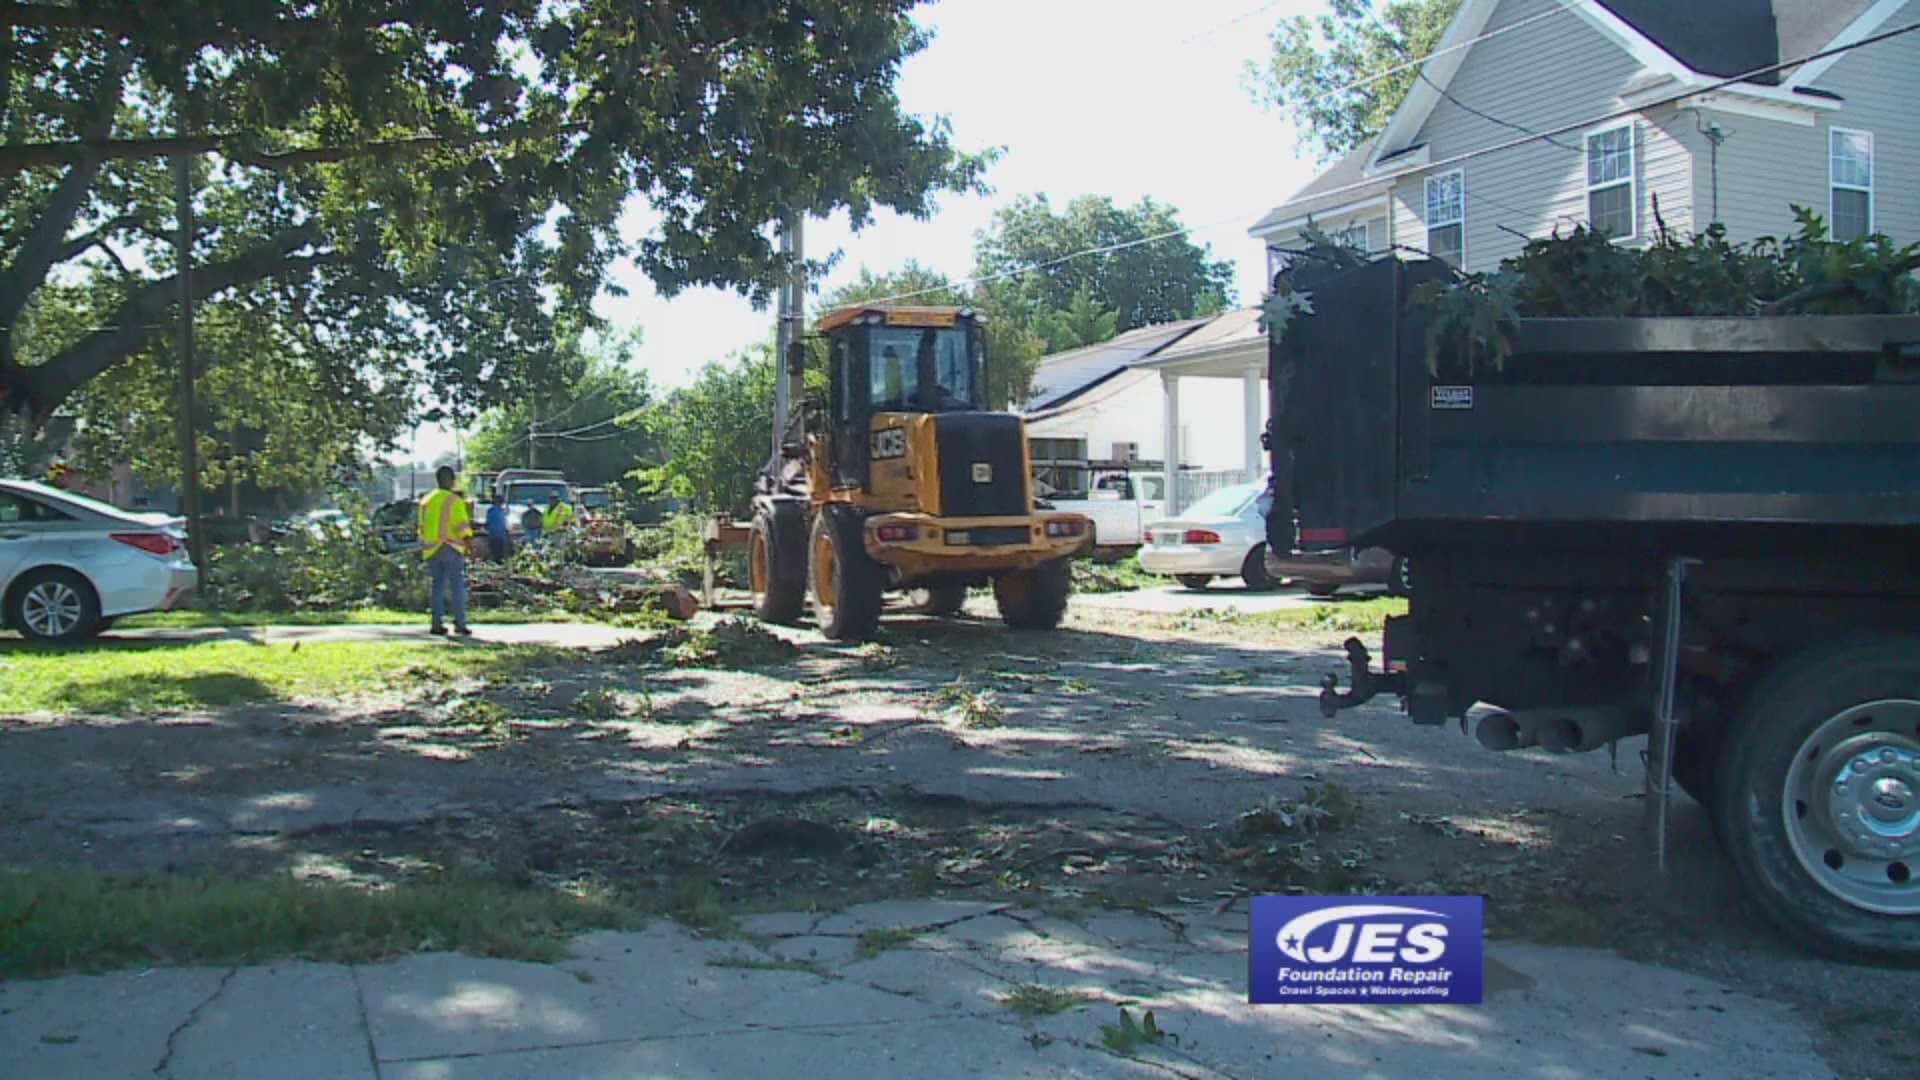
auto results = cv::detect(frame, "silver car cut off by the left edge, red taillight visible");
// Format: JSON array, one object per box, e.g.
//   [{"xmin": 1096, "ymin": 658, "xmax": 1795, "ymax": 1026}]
[{"xmin": 0, "ymin": 480, "xmax": 200, "ymax": 642}]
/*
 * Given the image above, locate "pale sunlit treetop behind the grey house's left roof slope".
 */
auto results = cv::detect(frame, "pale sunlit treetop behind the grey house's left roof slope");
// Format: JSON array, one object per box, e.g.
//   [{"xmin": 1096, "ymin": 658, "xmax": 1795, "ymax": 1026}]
[{"xmin": 1246, "ymin": 0, "xmax": 1459, "ymax": 160}]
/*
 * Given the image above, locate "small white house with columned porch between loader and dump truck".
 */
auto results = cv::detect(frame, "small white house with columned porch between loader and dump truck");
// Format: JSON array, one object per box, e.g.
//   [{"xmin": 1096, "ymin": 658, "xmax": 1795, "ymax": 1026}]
[{"xmin": 1023, "ymin": 307, "xmax": 1267, "ymax": 509}]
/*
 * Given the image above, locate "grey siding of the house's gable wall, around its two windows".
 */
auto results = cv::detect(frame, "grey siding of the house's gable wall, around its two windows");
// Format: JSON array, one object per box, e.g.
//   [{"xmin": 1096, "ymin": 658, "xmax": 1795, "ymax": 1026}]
[{"xmin": 1388, "ymin": 0, "xmax": 1724, "ymax": 271}]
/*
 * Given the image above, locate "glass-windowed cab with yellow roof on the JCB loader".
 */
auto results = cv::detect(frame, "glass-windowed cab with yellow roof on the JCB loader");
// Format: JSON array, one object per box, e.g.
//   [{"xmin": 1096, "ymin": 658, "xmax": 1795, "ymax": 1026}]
[{"xmin": 818, "ymin": 307, "xmax": 987, "ymax": 492}]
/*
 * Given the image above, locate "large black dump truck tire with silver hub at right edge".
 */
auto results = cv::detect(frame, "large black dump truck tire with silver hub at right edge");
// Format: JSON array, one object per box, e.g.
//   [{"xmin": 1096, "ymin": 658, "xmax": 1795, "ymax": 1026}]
[{"xmin": 1713, "ymin": 636, "xmax": 1920, "ymax": 965}]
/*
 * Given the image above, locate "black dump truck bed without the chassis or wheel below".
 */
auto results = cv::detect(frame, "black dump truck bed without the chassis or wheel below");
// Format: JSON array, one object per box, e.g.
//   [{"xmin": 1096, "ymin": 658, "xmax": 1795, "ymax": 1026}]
[{"xmin": 1269, "ymin": 259, "xmax": 1920, "ymax": 550}]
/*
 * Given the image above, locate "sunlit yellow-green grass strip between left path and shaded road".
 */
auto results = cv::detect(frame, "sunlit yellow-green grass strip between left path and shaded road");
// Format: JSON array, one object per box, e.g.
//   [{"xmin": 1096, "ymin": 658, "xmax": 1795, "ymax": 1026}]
[{"xmin": 0, "ymin": 640, "xmax": 566, "ymax": 715}]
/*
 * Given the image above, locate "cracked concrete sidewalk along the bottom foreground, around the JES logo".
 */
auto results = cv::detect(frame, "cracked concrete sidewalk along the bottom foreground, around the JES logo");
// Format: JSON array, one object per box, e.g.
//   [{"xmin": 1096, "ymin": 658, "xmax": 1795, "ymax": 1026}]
[{"xmin": 0, "ymin": 901, "xmax": 1832, "ymax": 1080}]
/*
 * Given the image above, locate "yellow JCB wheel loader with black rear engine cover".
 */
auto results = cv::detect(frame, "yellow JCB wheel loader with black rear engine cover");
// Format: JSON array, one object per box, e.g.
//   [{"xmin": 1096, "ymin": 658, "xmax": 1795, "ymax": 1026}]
[{"xmin": 747, "ymin": 307, "xmax": 1092, "ymax": 640}]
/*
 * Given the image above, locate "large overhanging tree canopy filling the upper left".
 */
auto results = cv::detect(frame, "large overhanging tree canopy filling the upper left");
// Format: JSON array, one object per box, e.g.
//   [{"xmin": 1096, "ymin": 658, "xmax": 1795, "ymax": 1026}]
[{"xmin": 0, "ymin": 0, "xmax": 985, "ymax": 438}]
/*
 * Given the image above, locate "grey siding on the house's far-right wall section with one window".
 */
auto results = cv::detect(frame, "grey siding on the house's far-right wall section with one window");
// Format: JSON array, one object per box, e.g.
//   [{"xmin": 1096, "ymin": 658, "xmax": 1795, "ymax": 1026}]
[{"xmin": 1701, "ymin": 2, "xmax": 1920, "ymax": 244}]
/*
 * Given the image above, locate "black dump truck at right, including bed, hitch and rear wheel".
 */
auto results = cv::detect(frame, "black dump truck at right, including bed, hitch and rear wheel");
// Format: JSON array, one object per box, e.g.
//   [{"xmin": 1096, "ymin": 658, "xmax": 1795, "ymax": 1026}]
[{"xmin": 1267, "ymin": 259, "xmax": 1920, "ymax": 961}]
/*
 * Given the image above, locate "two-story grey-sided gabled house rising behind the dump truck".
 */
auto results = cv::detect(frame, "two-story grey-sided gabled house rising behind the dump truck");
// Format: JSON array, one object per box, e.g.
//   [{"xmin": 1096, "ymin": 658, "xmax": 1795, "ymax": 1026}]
[{"xmin": 1250, "ymin": 0, "xmax": 1920, "ymax": 271}]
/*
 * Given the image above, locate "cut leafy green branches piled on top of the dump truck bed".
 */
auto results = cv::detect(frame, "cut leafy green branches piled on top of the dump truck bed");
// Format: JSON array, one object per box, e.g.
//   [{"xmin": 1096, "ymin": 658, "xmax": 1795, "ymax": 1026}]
[{"xmin": 1415, "ymin": 208, "xmax": 1920, "ymax": 373}]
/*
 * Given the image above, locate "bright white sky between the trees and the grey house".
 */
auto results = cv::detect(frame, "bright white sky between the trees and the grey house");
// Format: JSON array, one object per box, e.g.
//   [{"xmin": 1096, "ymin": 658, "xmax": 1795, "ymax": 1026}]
[{"xmin": 417, "ymin": 0, "xmax": 1323, "ymax": 459}]
